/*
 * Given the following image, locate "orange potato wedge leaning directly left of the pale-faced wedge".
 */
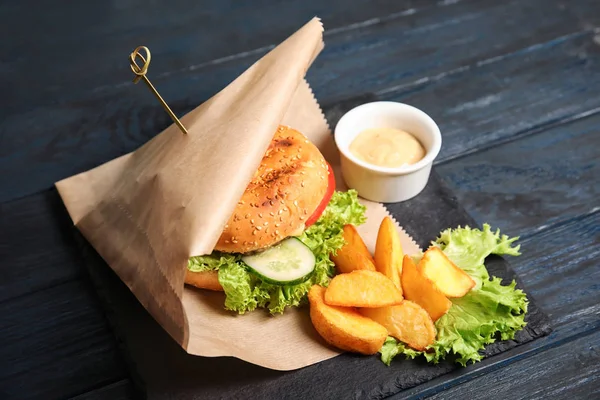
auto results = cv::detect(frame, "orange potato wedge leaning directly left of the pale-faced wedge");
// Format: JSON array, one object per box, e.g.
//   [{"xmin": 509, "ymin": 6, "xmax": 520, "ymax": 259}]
[{"xmin": 400, "ymin": 256, "xmax": 452, "ymax": 322}]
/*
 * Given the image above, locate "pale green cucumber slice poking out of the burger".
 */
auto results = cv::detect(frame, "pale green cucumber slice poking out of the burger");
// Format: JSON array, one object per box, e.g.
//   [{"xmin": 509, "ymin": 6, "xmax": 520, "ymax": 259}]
[{"xmin": 242, "ymin": 238, "xmax": 315, "ymax": 285}]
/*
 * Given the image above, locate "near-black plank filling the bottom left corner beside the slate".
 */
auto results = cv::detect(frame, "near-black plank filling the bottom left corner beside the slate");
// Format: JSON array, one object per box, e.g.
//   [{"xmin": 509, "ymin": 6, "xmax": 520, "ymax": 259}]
[{"xmin": 0, "ymin": 280, "xmax": 127, "ymax": 399}]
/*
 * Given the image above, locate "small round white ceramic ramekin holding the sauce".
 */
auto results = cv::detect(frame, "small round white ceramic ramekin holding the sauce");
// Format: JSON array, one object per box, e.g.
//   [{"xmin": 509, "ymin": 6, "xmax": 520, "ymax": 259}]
[{"xmin": 334, "ymin": 101, "xmax": 442, "ymax": 203}]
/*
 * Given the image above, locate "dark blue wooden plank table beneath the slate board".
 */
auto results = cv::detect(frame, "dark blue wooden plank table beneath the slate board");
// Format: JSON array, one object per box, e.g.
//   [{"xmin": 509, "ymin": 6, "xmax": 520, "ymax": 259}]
[{"xmin": 0, "ymin": 0, "xmax": 600, "ymax": 399}]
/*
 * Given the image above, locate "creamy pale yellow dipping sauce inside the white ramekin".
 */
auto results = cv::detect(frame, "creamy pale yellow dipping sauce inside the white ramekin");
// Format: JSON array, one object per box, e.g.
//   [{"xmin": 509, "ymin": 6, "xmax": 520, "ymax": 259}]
[{"xmin": 350, "ymin": 128, "xmax": 425, "ymax": 168}]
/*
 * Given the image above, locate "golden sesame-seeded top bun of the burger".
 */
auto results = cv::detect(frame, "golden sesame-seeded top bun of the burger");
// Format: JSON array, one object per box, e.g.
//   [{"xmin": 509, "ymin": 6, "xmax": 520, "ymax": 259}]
[{"xmin": 215, "ymin": 126, "xmax": 329, "ymax": 253}]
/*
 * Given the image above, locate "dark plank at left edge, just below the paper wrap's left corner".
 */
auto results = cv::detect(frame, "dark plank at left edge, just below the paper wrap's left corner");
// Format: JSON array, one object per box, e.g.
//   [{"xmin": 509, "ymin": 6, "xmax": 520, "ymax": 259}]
[{"xmin": 0, "ymin": 189, "xmax": 85, "ymax": 303}]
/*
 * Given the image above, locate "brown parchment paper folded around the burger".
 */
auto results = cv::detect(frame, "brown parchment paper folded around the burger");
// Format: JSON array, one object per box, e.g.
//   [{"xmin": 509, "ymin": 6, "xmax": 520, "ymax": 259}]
[{"xmin": 56, "ymin": 18, "xmax": 419, "ymax": 370}]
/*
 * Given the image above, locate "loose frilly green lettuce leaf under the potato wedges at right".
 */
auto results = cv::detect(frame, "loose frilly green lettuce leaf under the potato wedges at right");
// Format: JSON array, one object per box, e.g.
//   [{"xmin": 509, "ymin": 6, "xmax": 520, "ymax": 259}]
[{"xmin": 380, "ymin": 224, "xmax": 528, "ymax": 366}]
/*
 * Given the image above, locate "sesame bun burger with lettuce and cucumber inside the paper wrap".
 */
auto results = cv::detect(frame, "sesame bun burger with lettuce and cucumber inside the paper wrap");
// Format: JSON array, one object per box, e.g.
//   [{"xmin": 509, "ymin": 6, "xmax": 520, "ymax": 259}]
[{"xmin": 185, "ymin": 126, "xmax": 365, "ymax": 313}]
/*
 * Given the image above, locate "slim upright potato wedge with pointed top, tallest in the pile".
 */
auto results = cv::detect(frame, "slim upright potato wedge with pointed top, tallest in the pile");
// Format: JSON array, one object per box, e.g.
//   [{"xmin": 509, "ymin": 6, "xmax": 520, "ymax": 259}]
[{"xmin": 375, "ymin": 217, "xmax": 404, "ymax": 292}]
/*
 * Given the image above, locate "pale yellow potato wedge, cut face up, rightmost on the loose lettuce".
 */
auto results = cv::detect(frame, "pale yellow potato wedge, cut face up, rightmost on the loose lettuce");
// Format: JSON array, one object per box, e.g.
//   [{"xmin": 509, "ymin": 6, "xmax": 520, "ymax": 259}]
[{"xmin": 417, "ymin": 247, "xmax": 475, "ymax": 297}]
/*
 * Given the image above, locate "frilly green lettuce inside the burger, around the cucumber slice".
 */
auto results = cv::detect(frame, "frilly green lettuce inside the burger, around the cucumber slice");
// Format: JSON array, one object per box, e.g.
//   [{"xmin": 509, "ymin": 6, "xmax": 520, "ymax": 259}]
[{"xmin": 188, "ymin": 190, "xmax": 366, "ymax": 314}]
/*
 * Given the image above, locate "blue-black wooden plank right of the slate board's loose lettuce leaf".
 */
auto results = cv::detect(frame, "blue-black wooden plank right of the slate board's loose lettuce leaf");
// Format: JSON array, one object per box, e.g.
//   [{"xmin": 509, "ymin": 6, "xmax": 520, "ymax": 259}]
[{"xmin": 398, "ymin": 211, "xmax": 600, "ymax": 398}]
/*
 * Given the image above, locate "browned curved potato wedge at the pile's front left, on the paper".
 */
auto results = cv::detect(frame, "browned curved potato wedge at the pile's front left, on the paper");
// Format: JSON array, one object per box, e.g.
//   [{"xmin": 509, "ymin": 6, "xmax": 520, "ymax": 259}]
[{"xmin": 308, "ymin": 285, "xmax": 388, "ymax": 354}]
